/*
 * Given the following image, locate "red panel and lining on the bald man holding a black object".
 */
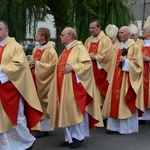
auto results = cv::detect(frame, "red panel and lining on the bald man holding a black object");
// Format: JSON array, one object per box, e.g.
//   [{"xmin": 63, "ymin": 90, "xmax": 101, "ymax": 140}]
[{"xmin": 110, "ymin": 49, "xmax": 136, "ymax": 118}]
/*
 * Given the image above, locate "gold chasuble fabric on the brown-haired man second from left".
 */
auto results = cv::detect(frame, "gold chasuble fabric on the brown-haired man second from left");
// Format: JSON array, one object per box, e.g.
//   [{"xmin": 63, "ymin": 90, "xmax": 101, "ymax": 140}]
[{"xmin": 32, "ymin": 43, "xmax": 58, "ymax": 119}]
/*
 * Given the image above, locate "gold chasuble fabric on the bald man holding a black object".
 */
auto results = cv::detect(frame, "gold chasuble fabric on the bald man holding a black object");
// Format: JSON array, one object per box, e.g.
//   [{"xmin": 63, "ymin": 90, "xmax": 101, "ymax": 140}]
[{"xmin": 102, "ymin": 40, "xmax": 144, "ymax": 119}]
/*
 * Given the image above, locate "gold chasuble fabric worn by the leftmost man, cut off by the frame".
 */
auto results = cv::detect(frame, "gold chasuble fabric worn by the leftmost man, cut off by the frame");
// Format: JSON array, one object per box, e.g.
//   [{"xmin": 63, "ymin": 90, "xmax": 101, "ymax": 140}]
[{"xmin": 0, "ymin": 38, "xmax": 42, "ymax": 133}]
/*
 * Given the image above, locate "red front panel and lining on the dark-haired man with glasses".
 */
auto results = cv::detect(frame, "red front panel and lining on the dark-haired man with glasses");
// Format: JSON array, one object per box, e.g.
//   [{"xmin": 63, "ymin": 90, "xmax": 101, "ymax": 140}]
[{"xmin": 89, "ymin": 41, "xmax": 108, "ymax": 96}]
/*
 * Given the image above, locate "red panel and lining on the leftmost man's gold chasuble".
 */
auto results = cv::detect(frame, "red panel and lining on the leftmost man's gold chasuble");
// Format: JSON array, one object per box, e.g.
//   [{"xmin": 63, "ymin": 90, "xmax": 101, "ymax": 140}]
[{"xmin": 0, "ymin": 46, "xmax": 43, "ymax": 129}]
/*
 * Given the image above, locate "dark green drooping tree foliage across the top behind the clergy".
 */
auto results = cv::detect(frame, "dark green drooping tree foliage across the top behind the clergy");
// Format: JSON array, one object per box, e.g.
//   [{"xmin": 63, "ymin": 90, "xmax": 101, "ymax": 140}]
[{"xmin": 0, "ymin": 0, "xmax": 136, "ymax": 53}]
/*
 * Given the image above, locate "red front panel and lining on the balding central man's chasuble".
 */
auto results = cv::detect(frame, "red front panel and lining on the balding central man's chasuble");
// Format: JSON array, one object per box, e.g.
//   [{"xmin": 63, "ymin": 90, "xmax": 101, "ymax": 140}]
[{"xmin": 57, "ymin": 49, "xmax": 98, "ymax": 128}]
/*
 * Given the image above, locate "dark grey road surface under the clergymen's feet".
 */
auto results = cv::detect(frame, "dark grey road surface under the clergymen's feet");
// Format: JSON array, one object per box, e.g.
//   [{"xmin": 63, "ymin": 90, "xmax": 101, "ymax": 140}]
[{"xmin": 33, "ymin": 123, "xmax": 150, "ymax": 150}]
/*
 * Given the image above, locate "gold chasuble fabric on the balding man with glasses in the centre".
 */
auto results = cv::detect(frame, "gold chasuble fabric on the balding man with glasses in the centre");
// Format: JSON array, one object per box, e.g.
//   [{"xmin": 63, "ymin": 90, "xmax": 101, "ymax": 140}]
[{"xmin": 47, "ymin": 40, "xmax": 103, "ymax": 127}]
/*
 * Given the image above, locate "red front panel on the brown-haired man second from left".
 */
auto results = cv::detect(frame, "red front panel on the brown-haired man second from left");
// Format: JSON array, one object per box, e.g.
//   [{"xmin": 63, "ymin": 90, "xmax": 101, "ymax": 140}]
[{"xmin": 31, "ymin": 49, "xmax": 44, "ymax": 88}]
